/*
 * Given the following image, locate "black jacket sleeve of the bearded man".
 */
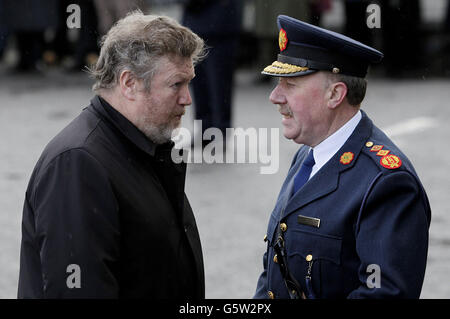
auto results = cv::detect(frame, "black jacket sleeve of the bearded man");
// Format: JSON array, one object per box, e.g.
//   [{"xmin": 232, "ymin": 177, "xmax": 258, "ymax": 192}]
[{"xmin": 31, "ymin": 149, "xmax": 120, "ymax": 298}]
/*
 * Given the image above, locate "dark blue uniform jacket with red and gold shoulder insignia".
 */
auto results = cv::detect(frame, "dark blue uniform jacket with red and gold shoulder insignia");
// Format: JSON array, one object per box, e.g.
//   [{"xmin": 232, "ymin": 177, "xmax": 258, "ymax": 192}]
[{"xmin": 255, "ymin": 112, "xmax": 431, "ymax": 298}]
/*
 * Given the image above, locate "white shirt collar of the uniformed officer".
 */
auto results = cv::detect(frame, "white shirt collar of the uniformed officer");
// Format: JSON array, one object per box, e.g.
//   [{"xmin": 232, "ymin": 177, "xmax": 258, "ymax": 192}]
[{"xmin": 310, "ymin": 110, "xmax": 362, "ymax": 178}]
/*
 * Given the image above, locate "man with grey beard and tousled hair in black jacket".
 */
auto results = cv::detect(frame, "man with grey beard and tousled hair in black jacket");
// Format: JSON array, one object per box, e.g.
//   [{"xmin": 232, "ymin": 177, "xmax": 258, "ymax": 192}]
[{"xmin": 18, "ymin": 12, "xmax": 205, "ymax": 299}]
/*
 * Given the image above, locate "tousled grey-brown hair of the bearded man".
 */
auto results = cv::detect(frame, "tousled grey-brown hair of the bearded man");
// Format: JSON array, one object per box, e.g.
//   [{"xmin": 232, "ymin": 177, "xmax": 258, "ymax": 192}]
[{"xmin": 88, "ymin": 10, "xmax": 205, "ymax": 93}]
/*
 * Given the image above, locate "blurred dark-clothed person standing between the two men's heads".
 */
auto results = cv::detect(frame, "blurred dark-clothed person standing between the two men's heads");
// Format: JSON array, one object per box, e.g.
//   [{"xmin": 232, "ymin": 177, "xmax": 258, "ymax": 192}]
[{"xmin": 182, "ymin": 0, "xmax": 242, "ymax": 144}]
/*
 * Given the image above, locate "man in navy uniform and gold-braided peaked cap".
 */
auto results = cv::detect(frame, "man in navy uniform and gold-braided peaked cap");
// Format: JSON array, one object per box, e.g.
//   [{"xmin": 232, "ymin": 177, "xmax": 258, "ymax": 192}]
[{"xmin": 254, "ymin": 16, "xmax": 431, "ymax": 299}]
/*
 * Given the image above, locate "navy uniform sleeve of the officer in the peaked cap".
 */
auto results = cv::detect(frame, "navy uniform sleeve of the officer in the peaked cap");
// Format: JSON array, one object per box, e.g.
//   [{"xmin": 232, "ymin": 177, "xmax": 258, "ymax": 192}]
[{"xmin": 348, "ymin": 171, "xmax": 430, "ymax": 298}]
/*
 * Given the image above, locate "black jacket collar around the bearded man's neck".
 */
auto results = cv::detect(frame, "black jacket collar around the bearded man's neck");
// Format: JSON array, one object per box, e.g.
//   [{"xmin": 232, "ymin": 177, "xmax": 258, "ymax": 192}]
[{"xmin": 91, "ymin": 95, "xmax": 174, "ymax": 156}]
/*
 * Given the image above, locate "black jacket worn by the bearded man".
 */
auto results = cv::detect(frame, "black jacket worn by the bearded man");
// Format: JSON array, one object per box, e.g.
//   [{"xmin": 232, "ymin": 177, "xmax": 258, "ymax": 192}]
[{"xmin": 18, "ymin": 97, "xmax": 205, "ymax": 299}]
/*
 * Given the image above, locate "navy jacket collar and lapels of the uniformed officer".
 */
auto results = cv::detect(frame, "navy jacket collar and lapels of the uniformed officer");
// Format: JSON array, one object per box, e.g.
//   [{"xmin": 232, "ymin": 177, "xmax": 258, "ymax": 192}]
[{"xmin": 282, "ymin": 111, "xmax": 373, "ymax": 218}]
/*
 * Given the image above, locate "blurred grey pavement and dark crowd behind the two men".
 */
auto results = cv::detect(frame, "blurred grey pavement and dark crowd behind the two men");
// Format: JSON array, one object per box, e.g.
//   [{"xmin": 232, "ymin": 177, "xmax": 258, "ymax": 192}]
[{"xmin": 0, "ymin": 0, "xmax": 450, "ymax": 298}]
